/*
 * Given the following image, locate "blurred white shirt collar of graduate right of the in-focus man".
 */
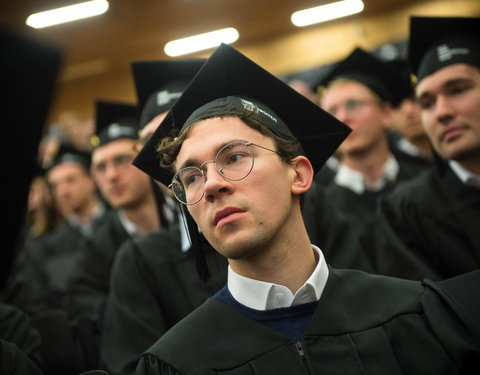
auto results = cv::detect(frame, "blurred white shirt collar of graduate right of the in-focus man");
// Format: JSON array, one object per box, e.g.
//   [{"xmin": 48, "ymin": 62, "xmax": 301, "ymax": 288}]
[{"xmin": 335, "ymin": 154, "xmax": 400, "ymax": 195}]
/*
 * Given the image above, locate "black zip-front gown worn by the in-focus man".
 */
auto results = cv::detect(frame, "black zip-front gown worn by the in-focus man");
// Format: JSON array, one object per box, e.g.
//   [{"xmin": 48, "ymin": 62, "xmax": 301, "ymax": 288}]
[{"xmin": 136, "ymin": 269, "xmax": 480, "ymax": 375}]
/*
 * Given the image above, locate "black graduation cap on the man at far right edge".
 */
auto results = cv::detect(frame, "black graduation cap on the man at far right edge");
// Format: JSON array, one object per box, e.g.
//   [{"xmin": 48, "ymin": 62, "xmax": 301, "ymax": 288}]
[{"xmin": 408, "ymin": 17, "xmax": 480, "ymax": 81}]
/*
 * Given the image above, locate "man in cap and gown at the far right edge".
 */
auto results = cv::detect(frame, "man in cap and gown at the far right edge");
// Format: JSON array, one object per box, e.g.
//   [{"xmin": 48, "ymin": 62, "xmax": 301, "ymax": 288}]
[{"xmin": 377, "ymin": 17, "xmax": 480, "ymax": 279}]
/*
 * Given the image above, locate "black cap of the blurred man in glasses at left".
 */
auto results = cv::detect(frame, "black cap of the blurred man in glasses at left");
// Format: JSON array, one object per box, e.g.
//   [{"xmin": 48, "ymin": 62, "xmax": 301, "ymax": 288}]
[{"xmin": 92, "ymin": 100, "xmax": 138, "ymax": 147}]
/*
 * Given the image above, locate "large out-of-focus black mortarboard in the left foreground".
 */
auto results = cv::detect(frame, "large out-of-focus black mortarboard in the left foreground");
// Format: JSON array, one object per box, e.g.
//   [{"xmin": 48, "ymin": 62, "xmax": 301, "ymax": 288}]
[{"xmin": 0, "ymin": 26, "xmax": 62, "ymax": 287}]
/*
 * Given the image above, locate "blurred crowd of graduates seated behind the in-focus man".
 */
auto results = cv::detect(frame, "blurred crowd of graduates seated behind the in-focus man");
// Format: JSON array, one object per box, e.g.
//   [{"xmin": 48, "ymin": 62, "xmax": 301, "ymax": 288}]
[{"xmin": 0, "ymin": 13, "xmax": 480, "ymax": 375}]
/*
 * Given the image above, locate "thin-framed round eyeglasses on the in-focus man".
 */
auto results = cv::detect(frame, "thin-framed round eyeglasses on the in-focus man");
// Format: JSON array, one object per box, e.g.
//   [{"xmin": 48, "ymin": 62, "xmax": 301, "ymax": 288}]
[{"xmin": 168, "ymin": 141, "xmax": 278, "ymax": 205}]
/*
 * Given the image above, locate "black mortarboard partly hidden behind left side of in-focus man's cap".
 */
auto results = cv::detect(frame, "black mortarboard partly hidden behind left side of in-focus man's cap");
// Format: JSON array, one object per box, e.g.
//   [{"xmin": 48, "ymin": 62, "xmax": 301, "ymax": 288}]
[{"xmin": 132, "ymin": 59, "xmax": 205, "ymax": 128}]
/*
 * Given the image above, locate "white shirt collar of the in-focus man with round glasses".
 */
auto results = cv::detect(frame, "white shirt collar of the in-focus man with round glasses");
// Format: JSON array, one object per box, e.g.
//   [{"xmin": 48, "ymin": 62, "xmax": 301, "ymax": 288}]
[{"xmin": 228, "ymin": 245, "xmax": 328, "ymax": 311}]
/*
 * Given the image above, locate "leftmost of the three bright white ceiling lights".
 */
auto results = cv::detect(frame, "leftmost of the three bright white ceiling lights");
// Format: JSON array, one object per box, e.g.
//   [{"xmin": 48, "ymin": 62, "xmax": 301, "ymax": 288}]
[{"xmin": 25, "ymin": 0, "xmax": 109, "ymax": 29}]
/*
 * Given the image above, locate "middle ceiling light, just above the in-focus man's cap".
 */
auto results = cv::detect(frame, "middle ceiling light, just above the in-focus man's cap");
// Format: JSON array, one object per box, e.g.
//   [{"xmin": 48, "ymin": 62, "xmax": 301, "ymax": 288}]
[{"xmin": 164, "ymin": 27, "xmax": 238, "ymax": 57}]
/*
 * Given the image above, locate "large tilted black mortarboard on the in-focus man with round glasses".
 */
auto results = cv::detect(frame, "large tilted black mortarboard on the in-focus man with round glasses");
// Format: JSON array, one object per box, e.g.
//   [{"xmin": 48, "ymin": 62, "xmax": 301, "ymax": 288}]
[{"xmin": 134, "ymin": 44, "xmax": 350, "ymax": 186}]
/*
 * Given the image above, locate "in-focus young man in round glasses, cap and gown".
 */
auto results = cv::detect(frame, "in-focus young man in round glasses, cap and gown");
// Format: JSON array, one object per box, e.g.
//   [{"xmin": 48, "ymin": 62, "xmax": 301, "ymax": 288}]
[{"xmin": 134, "ymin": 45, "xmax": 480, "ymax": 374}]
